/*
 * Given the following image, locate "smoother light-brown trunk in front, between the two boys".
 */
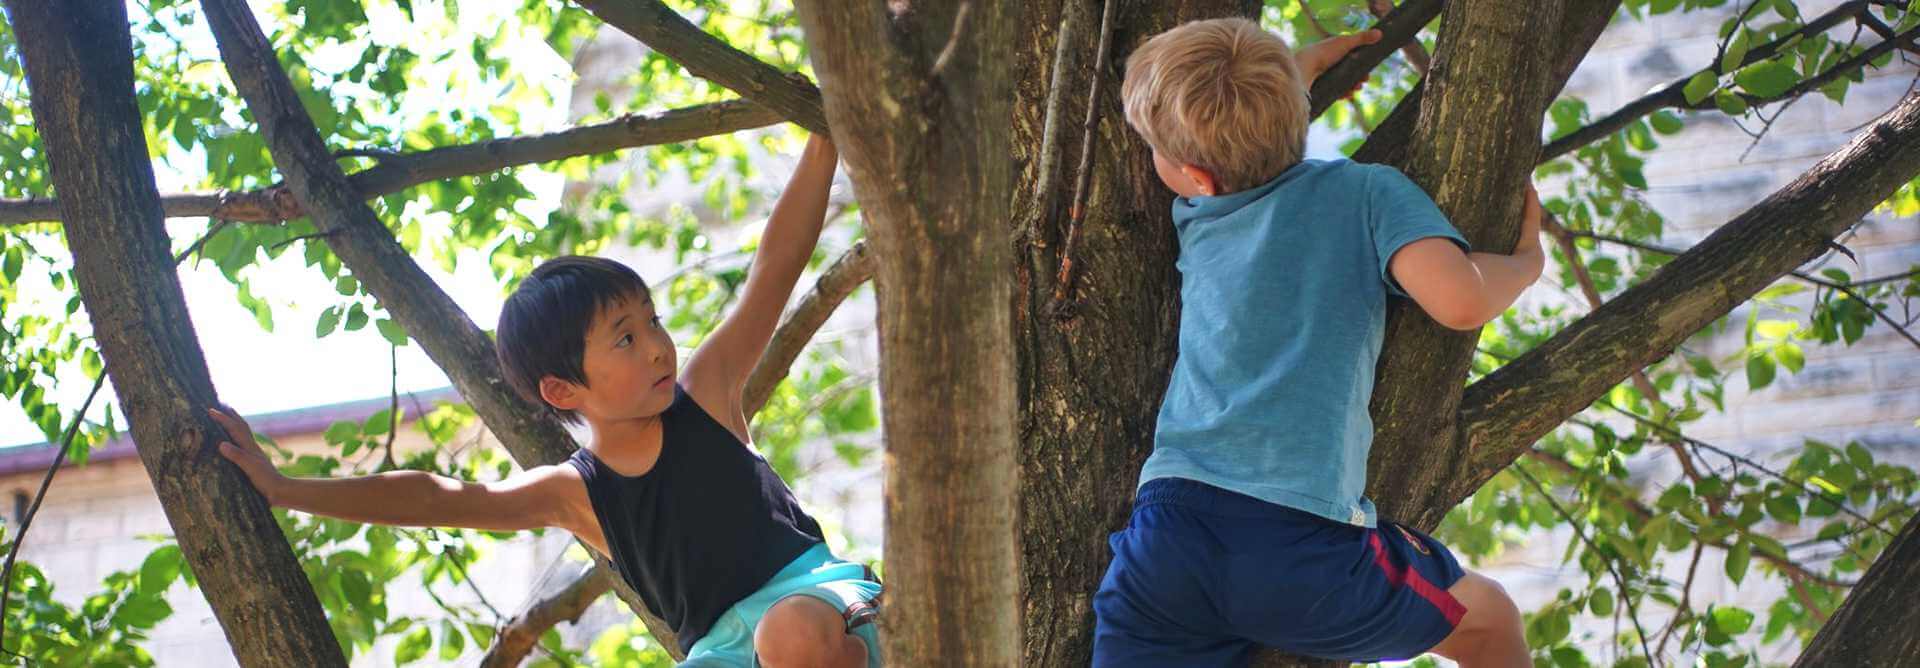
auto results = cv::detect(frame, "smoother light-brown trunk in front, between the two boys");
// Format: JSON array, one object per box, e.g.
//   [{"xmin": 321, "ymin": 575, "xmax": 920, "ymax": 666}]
[{"xmin": 797, "ymin": 0, "xmax": 1020, "ymax": 666}]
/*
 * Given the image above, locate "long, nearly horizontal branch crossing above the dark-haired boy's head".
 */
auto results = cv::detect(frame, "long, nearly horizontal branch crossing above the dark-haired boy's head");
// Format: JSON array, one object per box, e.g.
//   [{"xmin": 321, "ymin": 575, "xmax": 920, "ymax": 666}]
[{"xmin": 0, "ymin": 100, "xmax": 780, "ymax": 225}]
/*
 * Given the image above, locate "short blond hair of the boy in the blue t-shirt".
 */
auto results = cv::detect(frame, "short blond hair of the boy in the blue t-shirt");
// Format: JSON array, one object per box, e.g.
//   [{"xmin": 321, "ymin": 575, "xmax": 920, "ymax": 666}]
[{"xmin": 1119, "ymin": 19, "xmax": 1309, "ymax": 194}]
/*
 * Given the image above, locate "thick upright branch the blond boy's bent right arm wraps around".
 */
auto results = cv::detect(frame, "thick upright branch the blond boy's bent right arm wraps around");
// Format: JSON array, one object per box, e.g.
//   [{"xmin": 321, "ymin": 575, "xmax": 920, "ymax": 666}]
[{"xmin": 1367, "ymin": 0, "xmax": 1588, "ymax": 528}]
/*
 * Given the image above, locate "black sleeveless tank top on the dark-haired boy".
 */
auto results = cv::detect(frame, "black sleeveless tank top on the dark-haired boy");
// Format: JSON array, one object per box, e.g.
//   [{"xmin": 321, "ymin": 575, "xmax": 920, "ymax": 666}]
[{"xmin": 568, "ymin": 384, "xmax": 822, "ymax": 651}]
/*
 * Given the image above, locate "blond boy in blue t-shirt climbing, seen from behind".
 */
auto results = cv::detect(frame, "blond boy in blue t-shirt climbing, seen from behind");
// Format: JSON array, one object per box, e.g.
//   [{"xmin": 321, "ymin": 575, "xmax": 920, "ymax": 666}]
[{"xmin": 1094, "ymin": 19, "xmax": 1542, "ymax": 666}]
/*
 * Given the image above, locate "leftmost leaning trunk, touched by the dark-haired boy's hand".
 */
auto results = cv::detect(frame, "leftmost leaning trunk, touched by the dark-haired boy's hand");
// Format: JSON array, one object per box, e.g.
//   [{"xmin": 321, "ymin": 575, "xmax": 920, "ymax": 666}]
[{"xmin": 8, "ymin": 0, "xmax": 346, "ymax": 666}]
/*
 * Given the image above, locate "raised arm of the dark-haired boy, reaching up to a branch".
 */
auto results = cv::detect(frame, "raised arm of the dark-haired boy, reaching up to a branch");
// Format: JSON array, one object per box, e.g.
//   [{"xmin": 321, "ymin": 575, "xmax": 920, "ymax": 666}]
[{"xmin": 682, "ymin": 134, "xmax": 839, "ymax": 420}]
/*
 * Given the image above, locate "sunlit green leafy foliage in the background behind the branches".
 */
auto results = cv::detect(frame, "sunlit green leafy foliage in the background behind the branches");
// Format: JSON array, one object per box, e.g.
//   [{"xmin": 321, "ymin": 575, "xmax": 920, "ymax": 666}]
[{"xmin": 0, "ymin": 0, "xmax": 1920, "ymax": 666}]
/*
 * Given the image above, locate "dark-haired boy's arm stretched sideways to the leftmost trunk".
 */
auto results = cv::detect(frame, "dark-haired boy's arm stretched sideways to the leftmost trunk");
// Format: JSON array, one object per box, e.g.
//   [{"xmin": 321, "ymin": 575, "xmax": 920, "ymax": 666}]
[{"xmin": 209, "ymin": 411, "xmax": 599, "ymax": 539}]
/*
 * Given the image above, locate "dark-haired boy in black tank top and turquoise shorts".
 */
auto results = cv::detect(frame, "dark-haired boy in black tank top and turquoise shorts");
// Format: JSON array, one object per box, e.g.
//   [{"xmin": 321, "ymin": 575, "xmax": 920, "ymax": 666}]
[{"xmin": 215, "ymin": 136, "xmax": 879, "ymax": 668}]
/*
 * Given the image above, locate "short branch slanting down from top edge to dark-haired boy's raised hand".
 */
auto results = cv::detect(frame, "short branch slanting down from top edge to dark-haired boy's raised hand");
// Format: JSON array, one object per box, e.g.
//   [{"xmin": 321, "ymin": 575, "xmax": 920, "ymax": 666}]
[{"xmin": 576, "ymin": 0, "xmax": 825, "ymax": 134}]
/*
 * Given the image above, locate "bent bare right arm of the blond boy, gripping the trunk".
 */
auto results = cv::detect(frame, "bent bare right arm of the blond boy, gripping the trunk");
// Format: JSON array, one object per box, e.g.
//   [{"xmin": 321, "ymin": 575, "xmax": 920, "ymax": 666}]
[{"xmin": 1388, "ymin": 188, "xmax": 1546, "ymax": 330}]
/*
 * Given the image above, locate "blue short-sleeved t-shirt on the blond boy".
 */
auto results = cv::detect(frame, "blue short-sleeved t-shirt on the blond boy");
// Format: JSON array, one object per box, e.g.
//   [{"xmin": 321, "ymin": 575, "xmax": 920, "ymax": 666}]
[{"xmin": 1140, "ymin": 159, "xmax": 1467, "ymax": 526}]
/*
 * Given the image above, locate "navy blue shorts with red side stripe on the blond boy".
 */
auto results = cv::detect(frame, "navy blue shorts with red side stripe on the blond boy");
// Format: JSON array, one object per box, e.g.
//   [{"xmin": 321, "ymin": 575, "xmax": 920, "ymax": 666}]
[{"xmin": 1092, "ymin": 478, "xmax": 1467, "ymax": 668}]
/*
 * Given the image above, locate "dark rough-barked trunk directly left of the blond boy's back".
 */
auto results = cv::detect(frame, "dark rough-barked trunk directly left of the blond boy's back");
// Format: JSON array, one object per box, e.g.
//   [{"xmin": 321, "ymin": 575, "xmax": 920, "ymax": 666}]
[{"xmin": 1006, "ymin": 0, "xmax": 1260, "ymax": 666}]
